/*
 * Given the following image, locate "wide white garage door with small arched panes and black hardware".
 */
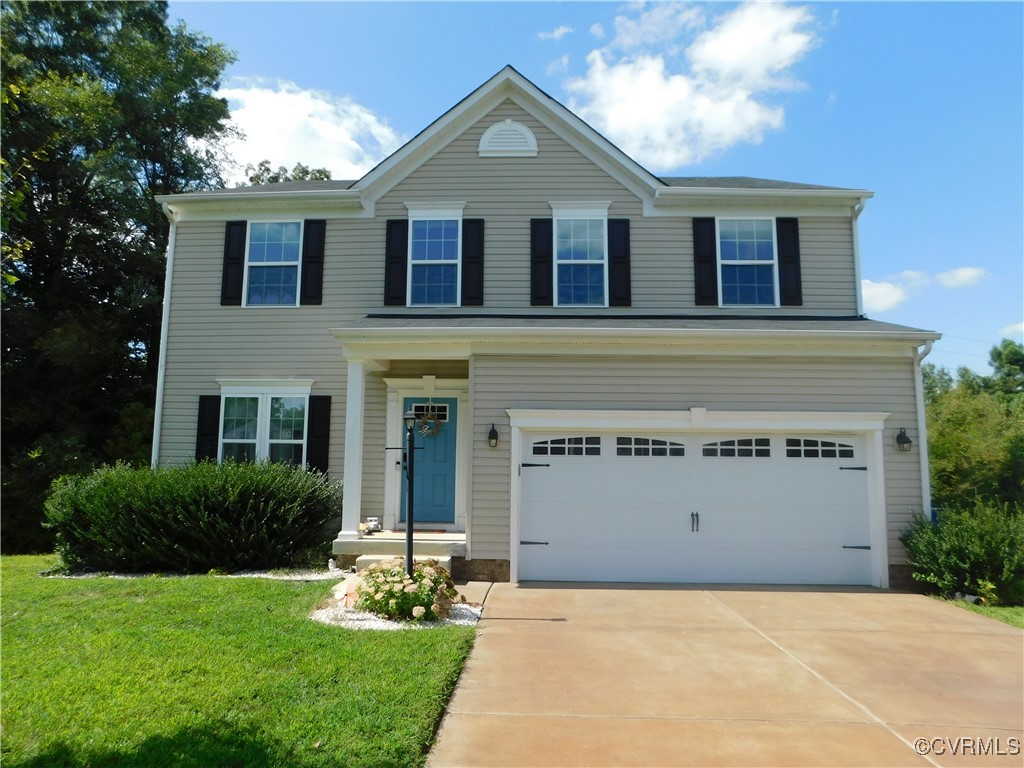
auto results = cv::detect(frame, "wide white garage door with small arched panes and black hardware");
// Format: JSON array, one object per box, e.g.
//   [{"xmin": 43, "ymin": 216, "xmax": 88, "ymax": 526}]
[{"xmin": 518, "ymin": 432, "xmax": 871, "ymax": 585}]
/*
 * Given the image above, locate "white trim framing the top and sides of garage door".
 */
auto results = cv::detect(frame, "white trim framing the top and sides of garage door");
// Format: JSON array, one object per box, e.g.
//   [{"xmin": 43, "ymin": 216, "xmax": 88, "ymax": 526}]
[{"xmin": 506, "ymin": 408, "xmax": 889, "ymax": 588}]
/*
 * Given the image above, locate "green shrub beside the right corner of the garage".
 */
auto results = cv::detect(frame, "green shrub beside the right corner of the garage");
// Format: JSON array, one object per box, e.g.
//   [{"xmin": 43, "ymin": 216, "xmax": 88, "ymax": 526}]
[{"xmin": 900, "ymin": 502, "xmax": 1024, "ymax": 605}]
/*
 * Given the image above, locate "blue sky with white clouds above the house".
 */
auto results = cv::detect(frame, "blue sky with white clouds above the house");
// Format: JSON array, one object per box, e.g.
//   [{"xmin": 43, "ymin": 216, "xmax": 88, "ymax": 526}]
[{"xmin": 170, "ymin": 1, "xmax": 1024, "ymax": 372}]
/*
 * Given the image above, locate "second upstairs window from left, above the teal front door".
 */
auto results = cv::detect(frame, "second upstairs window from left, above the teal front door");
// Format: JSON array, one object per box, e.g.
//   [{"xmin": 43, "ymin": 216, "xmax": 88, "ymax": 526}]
[{"xmin": 409, "ymin": 218, "xmax": 462, "ymax": 306}]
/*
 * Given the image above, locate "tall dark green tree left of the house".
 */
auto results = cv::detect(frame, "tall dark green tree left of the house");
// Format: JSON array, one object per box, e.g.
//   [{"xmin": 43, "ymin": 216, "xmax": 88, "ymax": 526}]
[{"xmin": 0, "ymin": 0, "xmax": 232, "ymax": 551}]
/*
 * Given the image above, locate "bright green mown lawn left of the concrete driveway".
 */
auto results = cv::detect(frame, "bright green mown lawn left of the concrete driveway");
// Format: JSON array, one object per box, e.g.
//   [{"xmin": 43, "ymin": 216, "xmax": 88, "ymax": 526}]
[{"xmin": 0, "ymin": 557, "xmax": 474, "ymax": 768}]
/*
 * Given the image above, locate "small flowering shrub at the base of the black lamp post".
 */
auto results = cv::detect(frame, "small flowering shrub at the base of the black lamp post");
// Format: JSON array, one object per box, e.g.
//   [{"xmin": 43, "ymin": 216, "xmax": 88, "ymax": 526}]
[{"xmin": 355, "ymin": 557, "xmax": 462, "ymax": 622}]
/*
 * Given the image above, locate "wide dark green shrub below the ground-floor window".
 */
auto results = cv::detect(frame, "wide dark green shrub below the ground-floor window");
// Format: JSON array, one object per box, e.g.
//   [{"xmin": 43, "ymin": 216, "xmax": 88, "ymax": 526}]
[{"xmin": 46, "ymin": 462, "xmax": 341, "ymax": 573}]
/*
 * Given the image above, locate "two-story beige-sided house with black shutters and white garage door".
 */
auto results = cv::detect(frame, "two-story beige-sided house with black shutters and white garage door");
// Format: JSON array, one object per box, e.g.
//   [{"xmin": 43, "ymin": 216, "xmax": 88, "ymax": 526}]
[{"xmin": 154, "ymin": 68, "xmax": 938, "ymax": 587}]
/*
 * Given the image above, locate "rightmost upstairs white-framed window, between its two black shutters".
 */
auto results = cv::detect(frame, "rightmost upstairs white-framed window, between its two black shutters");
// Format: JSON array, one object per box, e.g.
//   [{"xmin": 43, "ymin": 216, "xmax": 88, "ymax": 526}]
[{"xmin": 718, "ymin": 219, "xmax": 778, "ymax": 306}]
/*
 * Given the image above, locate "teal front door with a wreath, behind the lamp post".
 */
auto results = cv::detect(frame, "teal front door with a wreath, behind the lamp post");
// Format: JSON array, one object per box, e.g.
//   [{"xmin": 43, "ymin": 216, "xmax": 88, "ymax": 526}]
[{"xmin": 401, "ymin": 397, "xmax": 459, "ymax": 527}]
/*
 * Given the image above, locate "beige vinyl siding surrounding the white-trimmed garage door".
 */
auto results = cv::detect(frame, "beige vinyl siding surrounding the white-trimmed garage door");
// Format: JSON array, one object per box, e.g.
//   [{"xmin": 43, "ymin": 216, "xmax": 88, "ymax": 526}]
[{"xmin": 470, "ymin": 356, "xmax": 922, "ymax": 563}]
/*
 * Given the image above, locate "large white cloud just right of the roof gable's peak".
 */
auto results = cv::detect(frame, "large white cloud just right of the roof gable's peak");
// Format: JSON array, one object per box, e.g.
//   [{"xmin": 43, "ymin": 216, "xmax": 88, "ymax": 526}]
[{"xmin": 565, "ymin": 3, "xmax": 818, "ymax": 171}]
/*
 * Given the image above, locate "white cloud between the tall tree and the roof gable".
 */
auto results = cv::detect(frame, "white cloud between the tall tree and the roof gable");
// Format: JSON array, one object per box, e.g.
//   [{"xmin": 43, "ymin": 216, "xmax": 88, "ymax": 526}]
[{"xmin": 218, "ymin": 79, "xmax": 403, "ymax": 183}]
